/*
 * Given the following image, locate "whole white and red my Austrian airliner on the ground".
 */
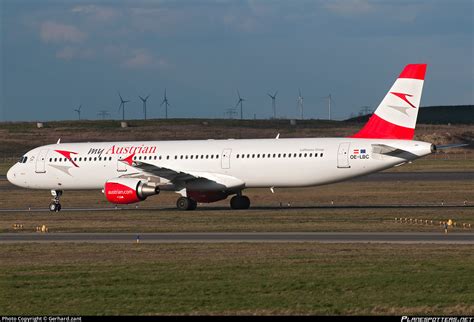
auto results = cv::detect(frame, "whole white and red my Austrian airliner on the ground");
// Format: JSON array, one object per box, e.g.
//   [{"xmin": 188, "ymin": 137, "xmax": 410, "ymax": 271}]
[{"xmin": 7, "ymin": 64, "xmax": 454, "ymax": 211}]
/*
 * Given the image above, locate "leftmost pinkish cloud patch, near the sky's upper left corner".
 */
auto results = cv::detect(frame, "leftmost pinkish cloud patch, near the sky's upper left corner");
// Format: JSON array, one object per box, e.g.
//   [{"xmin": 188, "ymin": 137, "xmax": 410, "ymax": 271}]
[{"xmin": 40, "ymin": 21, "xmax": 87, "ymax": 43}]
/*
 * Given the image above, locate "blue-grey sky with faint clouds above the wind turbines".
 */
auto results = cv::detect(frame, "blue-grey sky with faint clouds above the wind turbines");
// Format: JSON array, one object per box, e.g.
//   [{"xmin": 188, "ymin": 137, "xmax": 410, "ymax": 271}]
[{"xmin": 0, "ymin": 0, "xmax": 474, "ymax": 121}]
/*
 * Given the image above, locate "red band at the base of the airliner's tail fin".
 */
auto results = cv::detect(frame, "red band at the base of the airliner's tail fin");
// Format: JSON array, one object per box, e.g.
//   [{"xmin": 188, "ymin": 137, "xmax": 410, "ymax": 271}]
[{"xmin": 351, "ymin": 114, "xmax": 415, "ymax": 140}]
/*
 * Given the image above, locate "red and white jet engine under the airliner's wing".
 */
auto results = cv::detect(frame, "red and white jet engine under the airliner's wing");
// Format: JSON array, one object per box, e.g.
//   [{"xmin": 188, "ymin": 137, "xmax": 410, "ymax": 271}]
[{"xmin": 104, "ymin": 178, "xmax": 160, "ymax": 204}]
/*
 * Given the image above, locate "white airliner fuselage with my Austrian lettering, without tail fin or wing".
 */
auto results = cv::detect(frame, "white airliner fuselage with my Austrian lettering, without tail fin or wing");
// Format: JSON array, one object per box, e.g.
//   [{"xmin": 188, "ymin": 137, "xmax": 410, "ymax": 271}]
[{"xmin": 8, "ymin": 138, "xmax": 432, "ymax": 190}]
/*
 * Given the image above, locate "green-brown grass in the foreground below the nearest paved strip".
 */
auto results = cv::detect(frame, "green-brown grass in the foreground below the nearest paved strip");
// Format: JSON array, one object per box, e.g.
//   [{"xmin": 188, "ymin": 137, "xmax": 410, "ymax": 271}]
[{"xmin": 0, "ymin": 243, "xmax": 474, "ymax": 315}]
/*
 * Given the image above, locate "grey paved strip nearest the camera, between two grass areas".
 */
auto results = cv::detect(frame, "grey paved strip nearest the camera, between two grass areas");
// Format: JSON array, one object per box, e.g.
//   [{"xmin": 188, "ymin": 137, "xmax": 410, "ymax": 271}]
[{"xmin": 0, "ymin": 231, "xmax": 474, "ymax": 245}]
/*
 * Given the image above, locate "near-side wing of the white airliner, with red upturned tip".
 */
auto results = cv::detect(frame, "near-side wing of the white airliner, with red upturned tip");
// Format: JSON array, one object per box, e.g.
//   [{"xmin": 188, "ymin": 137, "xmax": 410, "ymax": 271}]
[{"xmin": 123, "ymin": 158, "xmax": 245, "ymax": 190}]
